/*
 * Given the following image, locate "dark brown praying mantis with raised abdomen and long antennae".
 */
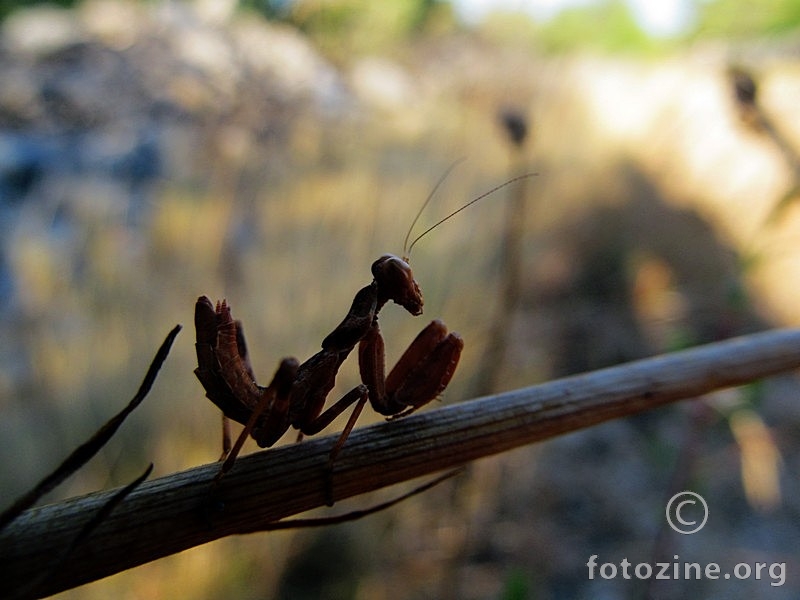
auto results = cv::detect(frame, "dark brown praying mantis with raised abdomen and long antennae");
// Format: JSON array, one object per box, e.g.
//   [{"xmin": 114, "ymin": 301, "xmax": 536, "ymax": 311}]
[{"xmin": 194, "ymin": 164, "xmax": 532, "ymax": 488}]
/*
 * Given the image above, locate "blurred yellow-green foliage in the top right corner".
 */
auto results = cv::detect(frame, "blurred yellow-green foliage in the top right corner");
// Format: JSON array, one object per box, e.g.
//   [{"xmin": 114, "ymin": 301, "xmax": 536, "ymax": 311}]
[{"xmin": 696, "ymin": 0, "xmax": 800, "ymax": 38}]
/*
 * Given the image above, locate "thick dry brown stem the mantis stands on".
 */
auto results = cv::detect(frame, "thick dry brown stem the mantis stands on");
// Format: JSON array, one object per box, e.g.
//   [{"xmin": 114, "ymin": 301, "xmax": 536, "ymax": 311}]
[{"xmin": 0, "ymin": 329, "xmax": 800, "ymax": 597}]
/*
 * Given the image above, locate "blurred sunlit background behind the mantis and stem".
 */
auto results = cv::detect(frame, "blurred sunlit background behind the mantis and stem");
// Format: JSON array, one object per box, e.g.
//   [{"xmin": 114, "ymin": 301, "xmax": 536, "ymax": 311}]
[{"xmin": 0, "ymin": 0, "xmax": 800, "ymax": 600}]
